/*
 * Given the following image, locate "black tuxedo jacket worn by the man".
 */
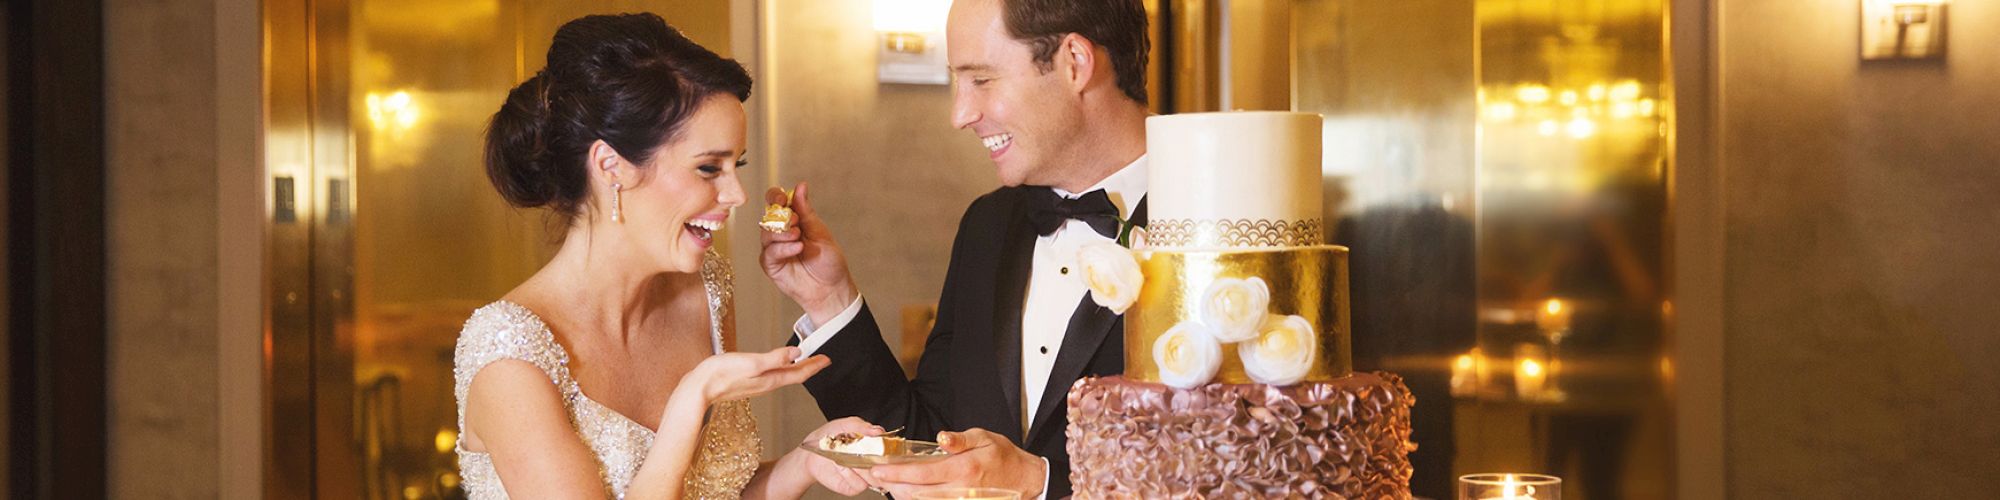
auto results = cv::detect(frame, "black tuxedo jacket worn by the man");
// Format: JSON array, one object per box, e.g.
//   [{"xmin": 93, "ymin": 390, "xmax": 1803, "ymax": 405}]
[{"xmin": 794, "ymin": 186, "xmax": 1146, "ymax": 498}]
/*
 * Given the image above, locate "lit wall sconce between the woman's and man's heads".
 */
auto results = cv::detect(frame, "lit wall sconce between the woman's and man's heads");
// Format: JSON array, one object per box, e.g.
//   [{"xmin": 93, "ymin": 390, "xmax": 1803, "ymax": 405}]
[{"xmin": 874, "ymin": 0, "xmax": 952, "ymax": 84}]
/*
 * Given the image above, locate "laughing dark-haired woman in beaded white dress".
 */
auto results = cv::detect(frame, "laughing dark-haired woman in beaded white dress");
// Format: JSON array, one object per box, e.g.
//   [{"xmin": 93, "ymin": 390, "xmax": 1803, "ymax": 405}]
[{"xmin": 452, "ymin": 14, "xmax": 880, "ymax": 498}]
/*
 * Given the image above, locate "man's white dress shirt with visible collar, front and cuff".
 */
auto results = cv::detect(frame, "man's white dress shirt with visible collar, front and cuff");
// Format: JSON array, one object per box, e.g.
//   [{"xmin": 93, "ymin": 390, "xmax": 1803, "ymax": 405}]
[{"xmin": 792, "ymin": 156, "xmax": 1146, "ymax": 492}]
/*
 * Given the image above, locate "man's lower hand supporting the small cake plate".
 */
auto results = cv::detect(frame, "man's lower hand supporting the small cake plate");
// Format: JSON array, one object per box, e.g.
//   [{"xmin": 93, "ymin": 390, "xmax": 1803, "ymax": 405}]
[{"xmin": 868, "ymin": 428, "xmax": 1048, "ymax": 498}]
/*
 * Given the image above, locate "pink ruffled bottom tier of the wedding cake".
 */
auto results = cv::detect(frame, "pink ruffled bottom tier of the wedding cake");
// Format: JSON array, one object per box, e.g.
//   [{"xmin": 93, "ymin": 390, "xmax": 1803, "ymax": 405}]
[{"xmin": 1068, "ymin": 372, "xmax": 1416, "ymax": 500}]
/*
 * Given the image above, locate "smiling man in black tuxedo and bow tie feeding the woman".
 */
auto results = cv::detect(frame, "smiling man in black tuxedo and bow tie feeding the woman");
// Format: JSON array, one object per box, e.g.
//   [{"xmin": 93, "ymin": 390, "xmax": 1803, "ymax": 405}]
[{"xmin": 762, "ymin": 0, "xmax": 1148, "ymax": 498}]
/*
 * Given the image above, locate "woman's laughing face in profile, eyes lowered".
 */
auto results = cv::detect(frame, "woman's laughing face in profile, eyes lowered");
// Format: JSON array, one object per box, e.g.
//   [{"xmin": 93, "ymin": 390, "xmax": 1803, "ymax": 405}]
[{"xmin": 598, "ymin": 94, "xmax": 744, "ymax": 272}]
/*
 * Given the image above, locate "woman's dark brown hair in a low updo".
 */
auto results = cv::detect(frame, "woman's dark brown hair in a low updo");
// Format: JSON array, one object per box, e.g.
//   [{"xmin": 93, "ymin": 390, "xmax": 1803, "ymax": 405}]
[{"xmin": 486, "ymin": 14, "xmax": 750, "ymax": 220}]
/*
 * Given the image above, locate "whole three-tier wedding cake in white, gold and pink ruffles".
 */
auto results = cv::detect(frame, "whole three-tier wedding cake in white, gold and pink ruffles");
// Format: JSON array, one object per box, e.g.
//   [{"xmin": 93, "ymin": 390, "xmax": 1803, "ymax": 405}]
[{"xmin": 1068, "ymin": 112, "xmax": 1416, "ymax": 498}]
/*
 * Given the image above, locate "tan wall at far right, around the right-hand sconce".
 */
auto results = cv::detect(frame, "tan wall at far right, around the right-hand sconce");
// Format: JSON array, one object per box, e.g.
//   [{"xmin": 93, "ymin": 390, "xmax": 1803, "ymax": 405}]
[{"xmin": 1716, "ymin": 0, "xmax": 2000, "ymax": 498}]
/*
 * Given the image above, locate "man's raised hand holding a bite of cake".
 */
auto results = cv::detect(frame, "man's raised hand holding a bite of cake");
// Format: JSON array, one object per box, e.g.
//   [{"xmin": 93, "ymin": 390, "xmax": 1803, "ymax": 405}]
[{"xmin": 760, "ymin": 182, "xmax": 860, "ymax": 324}]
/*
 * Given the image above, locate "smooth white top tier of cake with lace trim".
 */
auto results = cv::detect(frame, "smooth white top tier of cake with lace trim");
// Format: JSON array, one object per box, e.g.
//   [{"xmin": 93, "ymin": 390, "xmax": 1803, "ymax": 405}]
[{"xmin": 1146, "ymin": 112, "xmax": 1326, "ymax": 248}]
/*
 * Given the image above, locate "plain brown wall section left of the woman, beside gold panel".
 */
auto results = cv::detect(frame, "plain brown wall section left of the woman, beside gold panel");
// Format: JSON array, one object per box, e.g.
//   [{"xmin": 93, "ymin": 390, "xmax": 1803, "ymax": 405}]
[{"xmin": 100, "ymin": 0, "xmax": 262, "ymax": 498}]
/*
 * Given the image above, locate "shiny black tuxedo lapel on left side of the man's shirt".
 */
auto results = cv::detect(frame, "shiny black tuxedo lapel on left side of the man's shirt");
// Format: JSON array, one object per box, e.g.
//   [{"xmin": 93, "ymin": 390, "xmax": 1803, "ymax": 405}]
[{"xmin": 992, "ymin": 188, "xmax": 1036, "ymax": 442}]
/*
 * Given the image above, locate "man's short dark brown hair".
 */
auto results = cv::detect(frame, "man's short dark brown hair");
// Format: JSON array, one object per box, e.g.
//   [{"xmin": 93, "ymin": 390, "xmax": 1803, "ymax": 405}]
[{"xmin": 1002, "ymin": 0, "xmax": 1150, "ymax": 104}]
